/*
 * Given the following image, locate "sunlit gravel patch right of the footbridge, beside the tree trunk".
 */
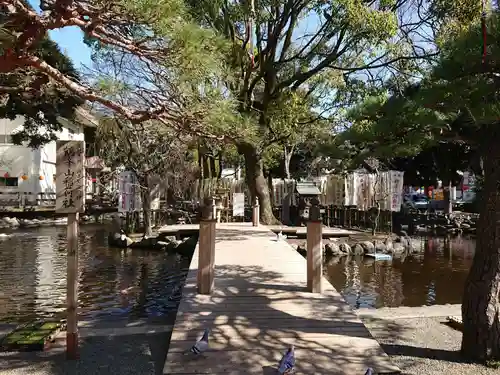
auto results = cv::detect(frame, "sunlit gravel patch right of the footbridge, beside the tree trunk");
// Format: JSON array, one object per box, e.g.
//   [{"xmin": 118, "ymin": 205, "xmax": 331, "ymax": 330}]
[{"xmin": 363, "ymin": 317, "xmax": 500, "ymax": 375}]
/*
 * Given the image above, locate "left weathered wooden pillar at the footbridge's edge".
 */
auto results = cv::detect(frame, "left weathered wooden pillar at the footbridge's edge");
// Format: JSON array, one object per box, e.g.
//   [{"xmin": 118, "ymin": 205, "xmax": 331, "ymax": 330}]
[{"xmin": 198, "ymin": 199, "xmax": 216, "ymax": 294}]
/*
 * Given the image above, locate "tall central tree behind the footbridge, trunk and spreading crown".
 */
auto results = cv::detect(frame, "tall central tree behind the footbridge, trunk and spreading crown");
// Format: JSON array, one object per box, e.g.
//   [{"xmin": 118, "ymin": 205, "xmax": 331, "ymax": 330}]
[{"xmin": 185, "ymin": 0, "xmax": 442, "ymax": 222}]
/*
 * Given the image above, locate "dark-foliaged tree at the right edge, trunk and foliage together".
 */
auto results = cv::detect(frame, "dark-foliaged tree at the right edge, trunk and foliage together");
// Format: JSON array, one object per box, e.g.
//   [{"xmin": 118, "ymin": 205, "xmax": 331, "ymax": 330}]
[{"xmin": 342, "ymin": 4, "xmax": 500, "ymax": 362}]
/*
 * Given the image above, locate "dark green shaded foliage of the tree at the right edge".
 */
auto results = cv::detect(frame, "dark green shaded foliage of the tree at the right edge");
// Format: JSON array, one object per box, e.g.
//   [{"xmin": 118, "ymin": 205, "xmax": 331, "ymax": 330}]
[{"xmin": 339, "ymin": 13, "xmax": 500, "ymax": 178}]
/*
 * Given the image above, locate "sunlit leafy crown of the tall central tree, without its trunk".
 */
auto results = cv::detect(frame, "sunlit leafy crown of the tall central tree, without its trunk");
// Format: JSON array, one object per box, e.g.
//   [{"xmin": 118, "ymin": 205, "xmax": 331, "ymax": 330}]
[{"xmin": 187, "ymin": 0, "xmax": 434, "ymax": 169}]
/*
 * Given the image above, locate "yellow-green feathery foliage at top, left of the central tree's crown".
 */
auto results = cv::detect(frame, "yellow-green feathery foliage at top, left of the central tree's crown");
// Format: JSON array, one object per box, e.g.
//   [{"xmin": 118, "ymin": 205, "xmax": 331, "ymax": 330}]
[{"xmin": 87, "ymin": 0, "xmax": 241, "ymax": 139}]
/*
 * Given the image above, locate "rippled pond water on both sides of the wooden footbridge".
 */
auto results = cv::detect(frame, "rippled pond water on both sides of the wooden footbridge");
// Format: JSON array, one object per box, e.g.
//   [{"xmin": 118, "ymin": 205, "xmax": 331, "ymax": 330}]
[{"xmin": 0, "ymin": 225, "xmax": 475, "ymax": 323}]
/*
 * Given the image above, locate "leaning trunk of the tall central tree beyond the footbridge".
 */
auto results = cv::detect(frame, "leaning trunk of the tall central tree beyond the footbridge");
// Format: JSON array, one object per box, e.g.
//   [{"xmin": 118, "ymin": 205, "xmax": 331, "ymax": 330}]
[{"xmin": 238, "ymin": 144, "xmax": 278, "ymax": 225}]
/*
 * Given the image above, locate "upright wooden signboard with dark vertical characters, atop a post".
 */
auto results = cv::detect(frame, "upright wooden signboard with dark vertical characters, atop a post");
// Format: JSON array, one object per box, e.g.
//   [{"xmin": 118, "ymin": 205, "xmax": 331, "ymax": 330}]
[{"xmin": 56, "ymin": 141, "xmax": 85, "ymax": 214}]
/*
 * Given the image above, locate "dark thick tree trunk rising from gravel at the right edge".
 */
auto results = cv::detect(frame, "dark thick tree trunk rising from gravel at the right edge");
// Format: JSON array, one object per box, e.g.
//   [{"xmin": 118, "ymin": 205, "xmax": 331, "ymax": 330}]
[{"xmin": 461, "ymin": 129, "xmax": 500, "ymax": 362}]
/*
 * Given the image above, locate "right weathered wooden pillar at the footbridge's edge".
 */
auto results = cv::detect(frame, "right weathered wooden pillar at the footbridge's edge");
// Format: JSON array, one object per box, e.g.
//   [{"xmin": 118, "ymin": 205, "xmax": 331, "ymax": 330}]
[{"xmin": 307, "ymin": 198, "xmax": 323, "ymax": 293}]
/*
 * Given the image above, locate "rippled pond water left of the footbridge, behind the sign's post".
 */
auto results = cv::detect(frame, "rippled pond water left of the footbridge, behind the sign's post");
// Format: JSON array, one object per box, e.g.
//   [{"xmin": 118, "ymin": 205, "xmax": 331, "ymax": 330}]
[{"xmin": 0, "ymin": 225, "xmax": 189, "ymax": 323}]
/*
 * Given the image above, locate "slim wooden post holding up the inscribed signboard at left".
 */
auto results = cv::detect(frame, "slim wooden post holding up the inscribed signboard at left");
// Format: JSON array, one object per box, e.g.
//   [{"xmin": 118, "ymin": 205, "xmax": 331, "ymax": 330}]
[{"xmin": 66, "ymin": 212, "xmax": 79, "ymax": 359}]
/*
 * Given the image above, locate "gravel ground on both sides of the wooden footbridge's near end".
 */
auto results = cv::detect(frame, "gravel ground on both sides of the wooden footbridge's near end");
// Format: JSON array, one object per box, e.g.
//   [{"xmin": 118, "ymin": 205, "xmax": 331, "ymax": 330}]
[{"xmin": 0, "ymin": 305, "xmax": 500, "ymax": 375}]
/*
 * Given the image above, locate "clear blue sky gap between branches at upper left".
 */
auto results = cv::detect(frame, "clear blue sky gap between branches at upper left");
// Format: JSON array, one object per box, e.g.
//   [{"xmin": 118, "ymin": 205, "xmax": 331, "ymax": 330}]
[{"xmin": 28, "ymin": 0, "xmax": 91, "ymax": 69}]
